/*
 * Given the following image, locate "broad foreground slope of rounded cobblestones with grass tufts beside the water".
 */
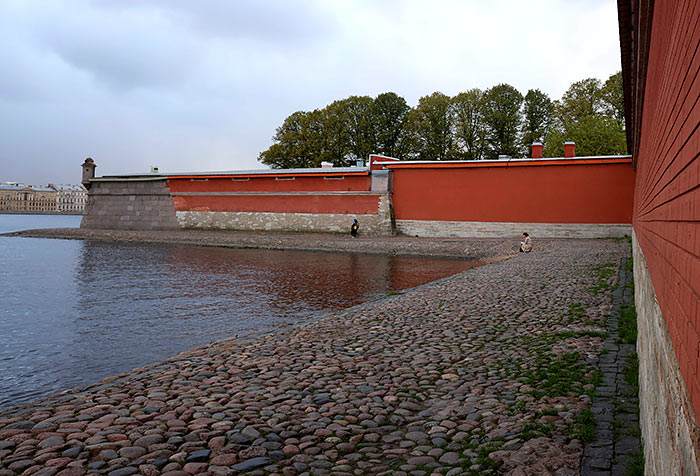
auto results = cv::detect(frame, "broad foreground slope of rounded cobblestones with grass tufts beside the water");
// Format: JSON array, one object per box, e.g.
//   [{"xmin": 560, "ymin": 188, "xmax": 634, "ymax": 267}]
[{"xmin": 0, "ymin": 240, "xmax": 629, "ymax": 476}]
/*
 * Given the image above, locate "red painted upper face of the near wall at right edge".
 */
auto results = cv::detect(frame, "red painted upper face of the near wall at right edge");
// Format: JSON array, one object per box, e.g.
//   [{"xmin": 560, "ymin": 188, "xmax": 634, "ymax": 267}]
[{"xmin": 634, "ymin": 0, "xmax": 700, "ymax": 416}]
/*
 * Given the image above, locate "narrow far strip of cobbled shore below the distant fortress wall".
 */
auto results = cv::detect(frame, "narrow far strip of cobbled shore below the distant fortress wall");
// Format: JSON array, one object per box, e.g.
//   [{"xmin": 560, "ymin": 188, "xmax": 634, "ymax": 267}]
[{"xmin": 0, "ymin": 228, "xmax": 532, "ymax": 260}]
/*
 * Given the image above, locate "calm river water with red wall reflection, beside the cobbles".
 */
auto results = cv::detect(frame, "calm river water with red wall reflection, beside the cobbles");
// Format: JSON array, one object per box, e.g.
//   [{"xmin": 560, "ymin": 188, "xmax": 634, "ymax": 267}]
[{"xmin": 0, "ymin": 215, "xmax": 471, "ymax": 409}]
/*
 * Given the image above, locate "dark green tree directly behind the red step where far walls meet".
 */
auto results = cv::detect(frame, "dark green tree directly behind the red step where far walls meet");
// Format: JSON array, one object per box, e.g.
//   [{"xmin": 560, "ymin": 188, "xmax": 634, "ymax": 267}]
[{"xmin": 371, "ymin": 93, "xmax": 411, "ymax": 159}]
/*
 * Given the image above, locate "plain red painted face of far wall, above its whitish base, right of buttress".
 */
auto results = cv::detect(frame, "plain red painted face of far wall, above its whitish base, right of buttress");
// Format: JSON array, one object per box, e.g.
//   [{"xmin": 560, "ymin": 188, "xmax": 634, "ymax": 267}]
[{"xmin": 389, "ymin": 159, "xmax": 634, "ymax": 223}]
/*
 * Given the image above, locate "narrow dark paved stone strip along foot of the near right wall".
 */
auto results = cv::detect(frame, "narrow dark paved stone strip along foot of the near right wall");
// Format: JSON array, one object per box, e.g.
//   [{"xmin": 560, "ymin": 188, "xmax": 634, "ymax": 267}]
[{"xmin": 581, "ymin": 258, "xmax": 640, "ymax": 476}]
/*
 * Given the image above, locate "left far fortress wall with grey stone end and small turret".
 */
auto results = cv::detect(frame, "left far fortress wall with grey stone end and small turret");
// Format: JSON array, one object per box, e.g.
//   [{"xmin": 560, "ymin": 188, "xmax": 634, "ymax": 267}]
[{"xmin": 81, "ymin": 166, "xmax": 394, "ymax": 235}]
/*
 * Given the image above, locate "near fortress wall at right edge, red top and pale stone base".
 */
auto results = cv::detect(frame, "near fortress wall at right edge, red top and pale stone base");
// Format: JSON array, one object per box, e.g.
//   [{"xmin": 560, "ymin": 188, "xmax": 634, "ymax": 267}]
[{"xmin": 618, "ymin": 0, "xmax": 700, "ymax": 475}]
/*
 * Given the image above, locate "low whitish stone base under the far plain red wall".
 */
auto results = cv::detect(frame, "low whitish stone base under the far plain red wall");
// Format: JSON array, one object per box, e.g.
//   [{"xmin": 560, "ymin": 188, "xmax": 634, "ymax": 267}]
[{"xmin": 396, "ymin": 220, "xmax": 632, "ymax": 238}]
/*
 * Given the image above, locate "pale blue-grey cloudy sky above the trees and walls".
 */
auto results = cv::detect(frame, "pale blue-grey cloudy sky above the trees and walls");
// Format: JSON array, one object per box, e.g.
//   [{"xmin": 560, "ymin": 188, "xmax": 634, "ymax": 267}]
[{"xmin": 0, "ymin": 0, "xmax": 620, "ymax": 184}]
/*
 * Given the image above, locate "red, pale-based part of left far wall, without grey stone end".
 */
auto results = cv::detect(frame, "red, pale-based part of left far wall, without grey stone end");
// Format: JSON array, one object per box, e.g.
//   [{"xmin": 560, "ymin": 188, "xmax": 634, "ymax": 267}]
[{"xmin": 168, "ymin": 168, "xmax": 393, "ymax": 235}]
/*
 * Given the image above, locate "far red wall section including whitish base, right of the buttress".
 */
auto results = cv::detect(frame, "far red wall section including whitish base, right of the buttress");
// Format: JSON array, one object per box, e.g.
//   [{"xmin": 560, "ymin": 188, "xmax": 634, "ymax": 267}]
[{"xmin": 385, "ymin": 157, "xmax": 634, "ymax": 237}]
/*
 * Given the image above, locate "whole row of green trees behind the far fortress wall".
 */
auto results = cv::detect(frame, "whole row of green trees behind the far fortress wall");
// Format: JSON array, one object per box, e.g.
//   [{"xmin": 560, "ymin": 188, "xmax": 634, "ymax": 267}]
[{"xmin": 258, "ymin": 72, "xmax": 627, "ymax": 168}]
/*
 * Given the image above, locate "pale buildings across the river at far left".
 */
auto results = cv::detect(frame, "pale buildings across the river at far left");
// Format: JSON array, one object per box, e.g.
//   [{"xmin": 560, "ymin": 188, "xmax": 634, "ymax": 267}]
[{"xmin": 0, "ymin": 182, "xmax": 87, "ymax": 214}]
